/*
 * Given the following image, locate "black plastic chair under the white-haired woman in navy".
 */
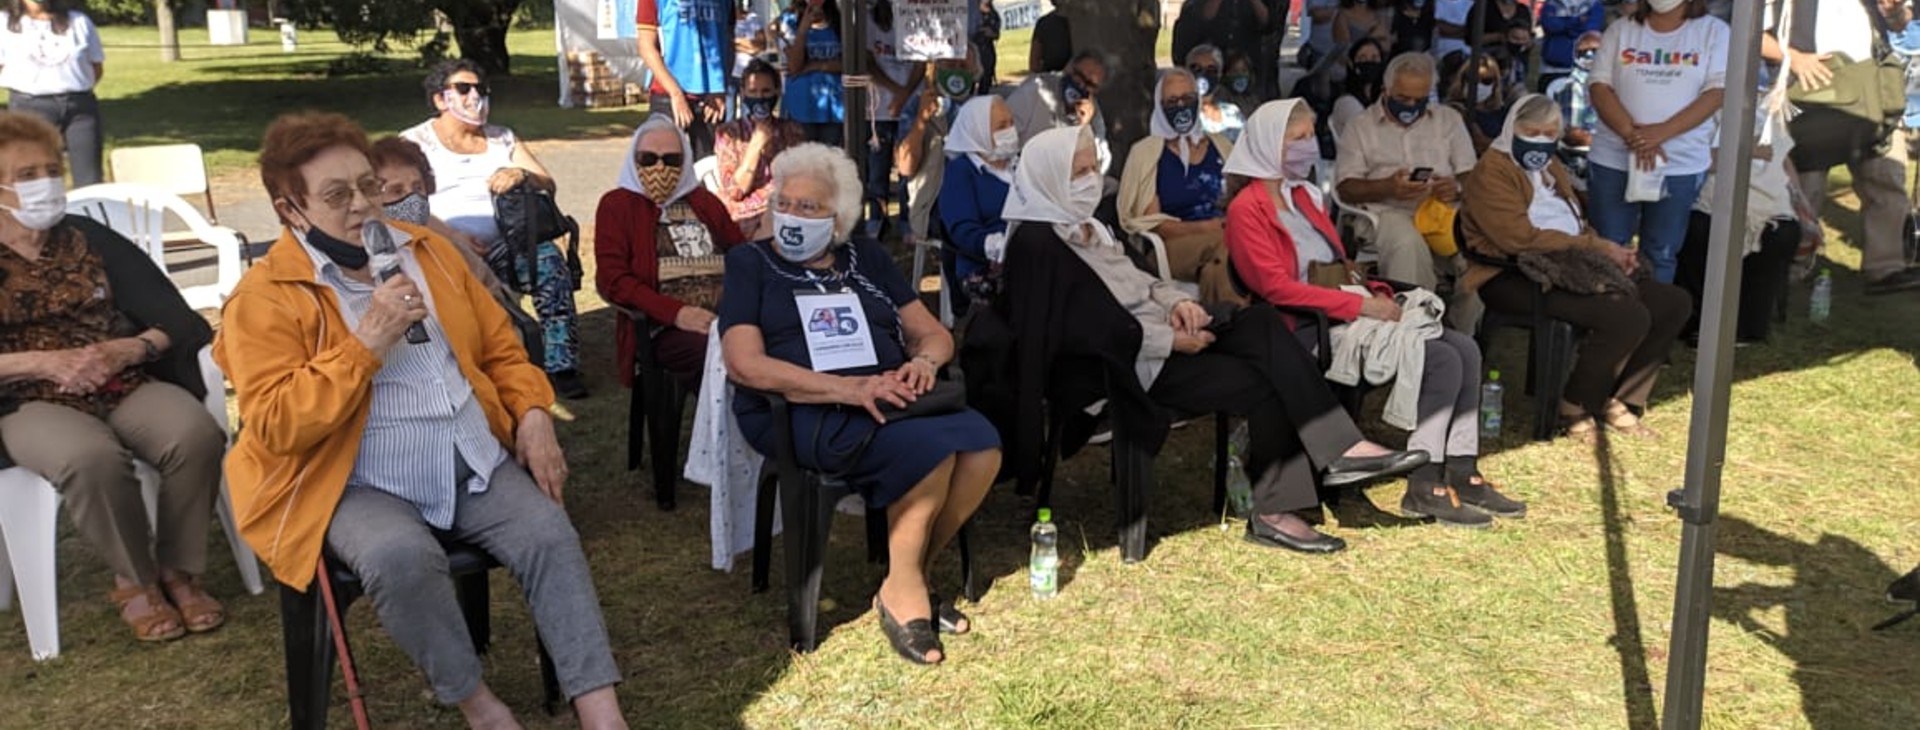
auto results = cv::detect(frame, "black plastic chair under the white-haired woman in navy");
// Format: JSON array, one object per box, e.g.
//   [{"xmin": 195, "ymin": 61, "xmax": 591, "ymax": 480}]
[{"xmin": 735, "ymin": 384, "xmax": 979, "ymax": 653}]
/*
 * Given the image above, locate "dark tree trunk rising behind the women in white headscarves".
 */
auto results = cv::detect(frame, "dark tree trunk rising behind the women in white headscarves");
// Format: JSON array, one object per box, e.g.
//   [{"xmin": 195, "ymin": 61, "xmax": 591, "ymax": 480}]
[{"xmin": 1054, "ymin": 0, "xmax": 1160, "ymax": 175}]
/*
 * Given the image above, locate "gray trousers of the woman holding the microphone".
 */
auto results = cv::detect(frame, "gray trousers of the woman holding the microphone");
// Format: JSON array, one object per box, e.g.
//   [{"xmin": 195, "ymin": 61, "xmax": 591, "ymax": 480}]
[{"xmin": 326, "ymin": 459, "xmax": 620, "ymax": 705}]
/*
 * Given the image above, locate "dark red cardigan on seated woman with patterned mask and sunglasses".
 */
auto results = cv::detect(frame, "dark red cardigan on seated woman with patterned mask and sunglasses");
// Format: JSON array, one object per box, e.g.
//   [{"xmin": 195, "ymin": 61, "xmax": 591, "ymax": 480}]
[{"xmin": 593, "ymin": 188, "xmax": 747, "ymax": 384}]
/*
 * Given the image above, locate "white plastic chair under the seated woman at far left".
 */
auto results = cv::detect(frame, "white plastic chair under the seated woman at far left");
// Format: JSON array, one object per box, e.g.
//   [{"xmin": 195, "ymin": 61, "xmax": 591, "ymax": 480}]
[{"xmin": 0, "ymin": 348, "xmax": 265, "ymax": 661}]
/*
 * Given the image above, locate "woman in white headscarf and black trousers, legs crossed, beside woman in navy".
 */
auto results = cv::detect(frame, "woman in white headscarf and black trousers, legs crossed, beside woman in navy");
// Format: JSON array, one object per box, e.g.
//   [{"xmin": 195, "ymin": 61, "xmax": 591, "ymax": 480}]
[{"xmin": 1006, "ymin": 129, "xmax": 1427, "ymax": 553}]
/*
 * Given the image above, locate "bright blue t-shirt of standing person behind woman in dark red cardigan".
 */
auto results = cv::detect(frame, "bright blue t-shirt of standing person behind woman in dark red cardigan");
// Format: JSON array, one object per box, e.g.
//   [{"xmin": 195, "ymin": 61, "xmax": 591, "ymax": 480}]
[{"xmin": 634, "ymin": 0, "xmax": 733, "ymax": 94}]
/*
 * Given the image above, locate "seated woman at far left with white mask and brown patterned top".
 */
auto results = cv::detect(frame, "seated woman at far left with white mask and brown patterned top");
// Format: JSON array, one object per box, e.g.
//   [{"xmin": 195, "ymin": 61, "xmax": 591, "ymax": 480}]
[{"xmin": 0, "ymin": 111, "xmax": 227, "ymax": 642}]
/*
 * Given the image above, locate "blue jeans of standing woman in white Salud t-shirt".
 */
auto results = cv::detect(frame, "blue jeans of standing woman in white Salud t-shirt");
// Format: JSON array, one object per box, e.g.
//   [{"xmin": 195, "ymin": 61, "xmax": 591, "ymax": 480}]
[{"xmin": 1586, "ymin": 163, "xmax": 1707, "ymax": 284}]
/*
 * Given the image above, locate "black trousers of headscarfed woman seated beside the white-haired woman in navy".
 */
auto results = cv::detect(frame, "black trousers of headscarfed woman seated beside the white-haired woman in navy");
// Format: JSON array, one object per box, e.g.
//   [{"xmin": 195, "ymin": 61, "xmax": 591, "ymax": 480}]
[{"xmin": 1148, "ymin": 305, "xmax": 1363, "ymax": 515}]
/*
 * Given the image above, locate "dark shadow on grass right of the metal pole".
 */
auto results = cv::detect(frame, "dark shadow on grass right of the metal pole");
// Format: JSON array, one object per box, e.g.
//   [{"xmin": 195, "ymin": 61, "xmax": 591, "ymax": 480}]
[{"xmin": 1713, "ymin": 515, "xmax": 1920, "ymax": 730}]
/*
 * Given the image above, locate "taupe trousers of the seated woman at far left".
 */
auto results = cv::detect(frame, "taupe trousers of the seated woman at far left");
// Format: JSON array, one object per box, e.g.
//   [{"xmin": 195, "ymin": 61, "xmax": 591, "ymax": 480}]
[{"xmin": 0, "ymin": 380, "xmax": 227, "ymax": 586}]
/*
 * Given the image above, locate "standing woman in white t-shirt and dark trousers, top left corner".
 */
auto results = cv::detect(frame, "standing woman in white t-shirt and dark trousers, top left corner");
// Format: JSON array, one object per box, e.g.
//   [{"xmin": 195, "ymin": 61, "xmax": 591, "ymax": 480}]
[{"xmin": 0, "ymin": 0, "xmax": 108, "ymax": 188}]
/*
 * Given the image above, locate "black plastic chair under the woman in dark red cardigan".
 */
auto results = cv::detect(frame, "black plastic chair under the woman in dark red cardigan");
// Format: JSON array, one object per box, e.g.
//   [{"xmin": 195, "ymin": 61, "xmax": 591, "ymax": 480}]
[{"xmin": 609, "ymin": 304, "xmax": 691, "ymax": 511}]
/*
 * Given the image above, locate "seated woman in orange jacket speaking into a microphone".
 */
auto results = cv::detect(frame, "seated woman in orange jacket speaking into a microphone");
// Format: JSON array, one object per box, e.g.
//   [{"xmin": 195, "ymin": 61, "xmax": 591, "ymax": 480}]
[{"xmin": 215, "ymin": 113, "xmax": 626, "ymax": 728}]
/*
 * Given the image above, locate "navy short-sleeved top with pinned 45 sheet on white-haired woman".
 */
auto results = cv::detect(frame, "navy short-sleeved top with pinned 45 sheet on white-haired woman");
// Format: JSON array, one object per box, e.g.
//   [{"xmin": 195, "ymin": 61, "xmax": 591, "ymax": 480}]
[{"xmin": 716, "ymin": 238, "xmax": 918, "ymax": 413}]
